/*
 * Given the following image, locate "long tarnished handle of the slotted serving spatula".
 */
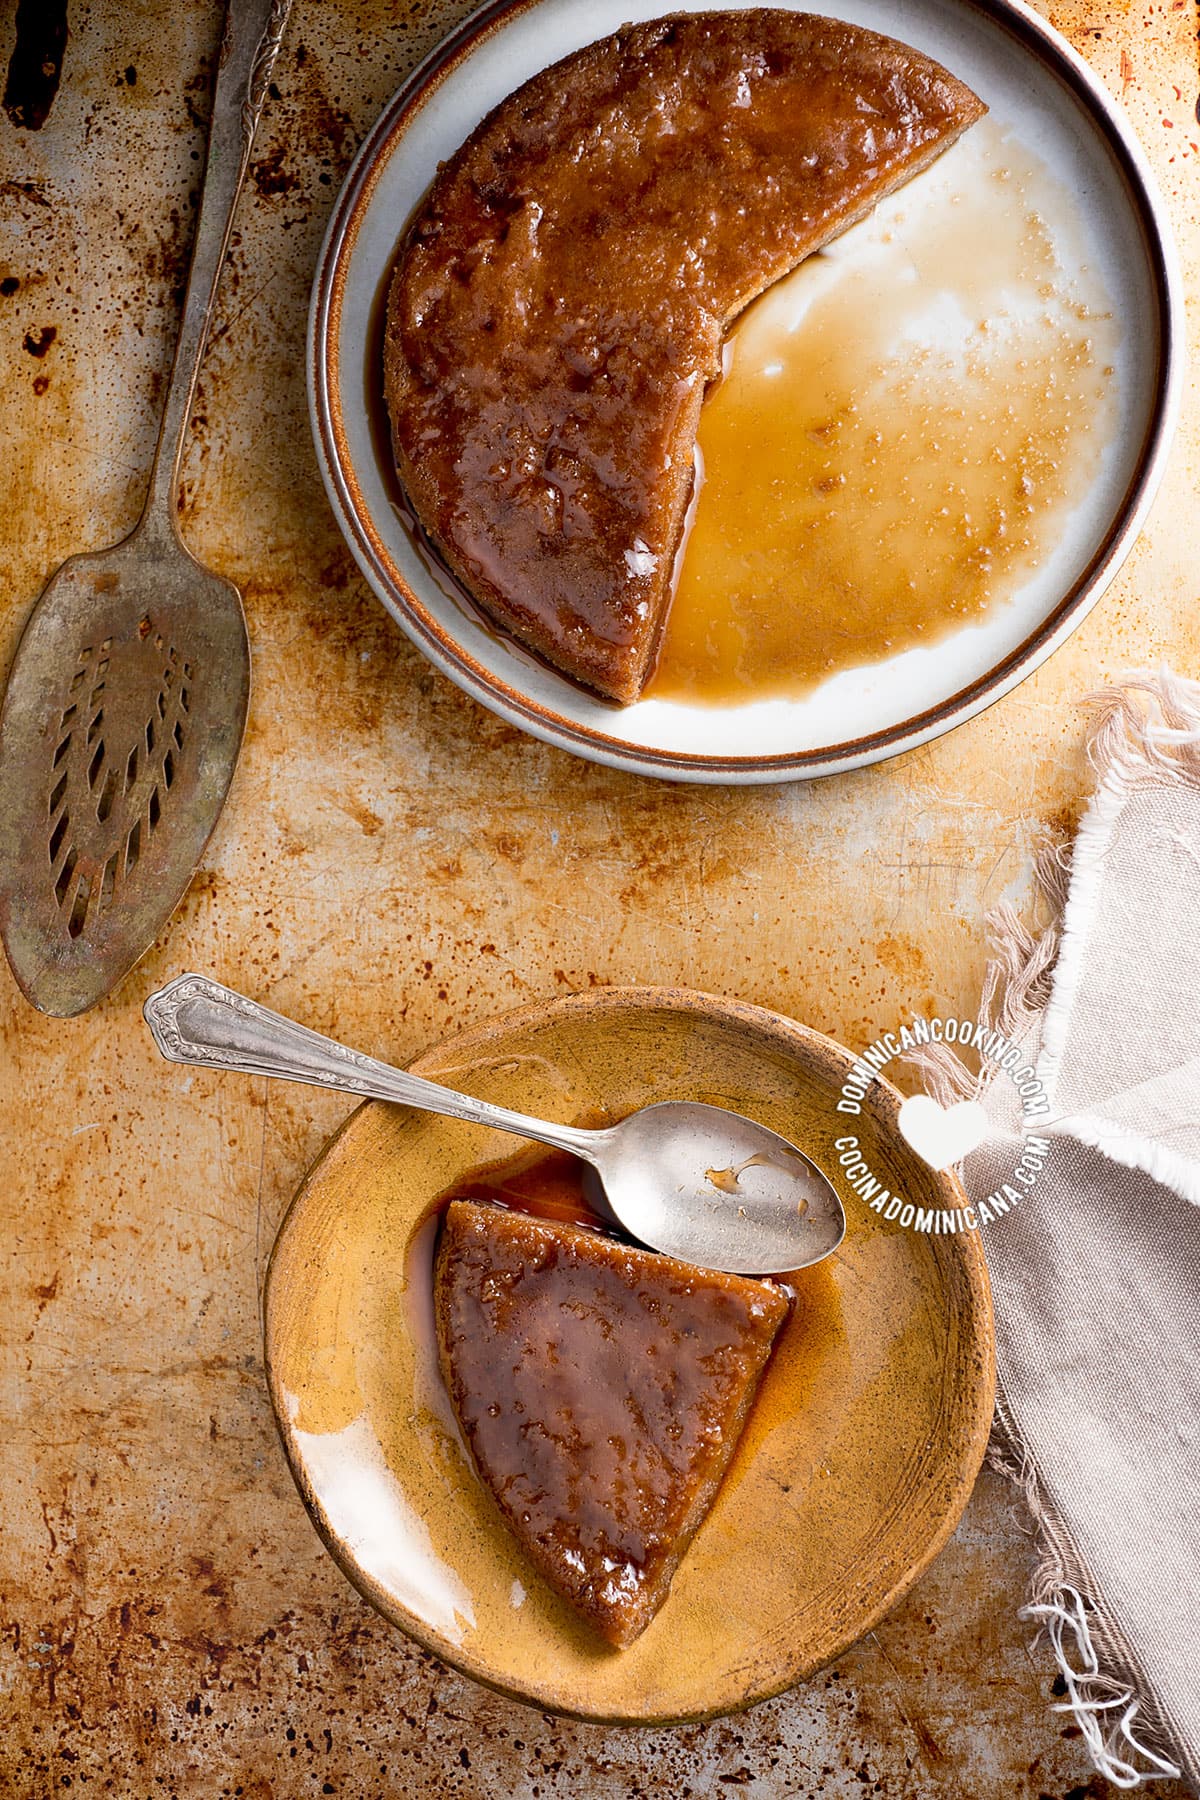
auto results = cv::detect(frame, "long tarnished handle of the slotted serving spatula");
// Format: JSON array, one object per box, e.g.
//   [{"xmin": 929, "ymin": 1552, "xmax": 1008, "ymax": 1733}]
[{"xmin": 140, "ymin": 0, "xmax": 291, "ymax": 533}]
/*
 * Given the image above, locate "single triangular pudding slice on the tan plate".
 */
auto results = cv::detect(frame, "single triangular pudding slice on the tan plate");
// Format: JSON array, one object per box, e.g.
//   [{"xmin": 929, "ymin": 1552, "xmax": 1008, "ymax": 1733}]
[{"xmin": 434, "ymin": 1201, "xmax": 788, "ymax": 1647}]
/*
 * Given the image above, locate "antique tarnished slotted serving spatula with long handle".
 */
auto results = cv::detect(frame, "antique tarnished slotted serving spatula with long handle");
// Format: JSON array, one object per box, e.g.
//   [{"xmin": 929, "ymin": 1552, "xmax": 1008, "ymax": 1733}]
[{"xmin": 0, "ymin": 0, "xmax": 291, "ymax": 1017}]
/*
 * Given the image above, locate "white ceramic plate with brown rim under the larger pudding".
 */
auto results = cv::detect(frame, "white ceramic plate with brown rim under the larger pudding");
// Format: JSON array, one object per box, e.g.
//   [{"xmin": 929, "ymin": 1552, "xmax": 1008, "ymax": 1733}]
[{"xmin": 308, "ymin": 0, "xmax": 1182, "ymax": 783}]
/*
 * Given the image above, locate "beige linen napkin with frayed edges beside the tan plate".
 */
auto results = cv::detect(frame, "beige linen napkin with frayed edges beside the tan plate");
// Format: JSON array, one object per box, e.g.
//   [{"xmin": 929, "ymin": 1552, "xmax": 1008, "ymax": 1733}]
[{"xmin": 916, "ymin": 673, "xmax": 1200, "ymax": 1787}]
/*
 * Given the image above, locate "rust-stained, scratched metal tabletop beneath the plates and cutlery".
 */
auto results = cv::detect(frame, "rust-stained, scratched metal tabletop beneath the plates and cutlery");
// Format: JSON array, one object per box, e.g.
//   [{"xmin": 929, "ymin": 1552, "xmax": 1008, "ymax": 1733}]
[{"xmin": 0, "ymin": 0, "xmax": 1200, "ymax": 1800}]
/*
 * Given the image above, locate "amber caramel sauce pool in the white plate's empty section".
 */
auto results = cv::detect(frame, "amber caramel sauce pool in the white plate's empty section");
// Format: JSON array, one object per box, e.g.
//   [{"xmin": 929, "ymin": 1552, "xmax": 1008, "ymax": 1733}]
[{"xmin": 648, "ymin": 121, "xmax": 1117, "ymax": 704}]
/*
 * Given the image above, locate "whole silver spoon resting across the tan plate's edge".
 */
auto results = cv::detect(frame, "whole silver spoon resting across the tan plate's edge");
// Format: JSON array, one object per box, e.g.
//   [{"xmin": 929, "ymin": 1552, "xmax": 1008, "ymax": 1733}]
[{"xmin": 144, "ymin": 976, "xmax": 846, "ymax": 1274}]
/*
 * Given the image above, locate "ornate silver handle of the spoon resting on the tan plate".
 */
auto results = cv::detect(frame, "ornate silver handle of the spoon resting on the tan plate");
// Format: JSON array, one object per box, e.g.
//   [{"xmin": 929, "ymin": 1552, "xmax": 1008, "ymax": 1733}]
[{"xmin": 142, "ymin": 976, "xmax": 606, "ymax": 1159}]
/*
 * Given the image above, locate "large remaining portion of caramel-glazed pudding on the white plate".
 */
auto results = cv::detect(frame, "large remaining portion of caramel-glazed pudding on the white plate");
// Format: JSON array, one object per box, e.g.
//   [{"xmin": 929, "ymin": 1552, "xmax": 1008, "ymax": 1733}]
[{"xmin": 383, "ymin": 9, "xmax": 986, "ymax": 702}]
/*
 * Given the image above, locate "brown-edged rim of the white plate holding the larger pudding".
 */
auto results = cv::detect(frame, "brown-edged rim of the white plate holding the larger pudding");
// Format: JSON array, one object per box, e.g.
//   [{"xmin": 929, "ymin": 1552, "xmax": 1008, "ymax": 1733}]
[{"xmin": 308, "ymin": 0, "xmax": 1184, "ymax": 781}]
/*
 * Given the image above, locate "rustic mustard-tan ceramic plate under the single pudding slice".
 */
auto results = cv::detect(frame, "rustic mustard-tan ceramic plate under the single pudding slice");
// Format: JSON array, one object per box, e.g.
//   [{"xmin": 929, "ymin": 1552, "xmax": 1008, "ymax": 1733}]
[{"xmin": 266, "ymin": 988, "xmax": 993, "ymax": 1723}]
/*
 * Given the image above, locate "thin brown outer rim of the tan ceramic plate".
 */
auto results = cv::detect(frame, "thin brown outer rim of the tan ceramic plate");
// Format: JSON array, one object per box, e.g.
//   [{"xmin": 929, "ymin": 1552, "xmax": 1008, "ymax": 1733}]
[{"xmin": 261, "ymin": 986, "xmax": 997, "ymax": 1726}]
